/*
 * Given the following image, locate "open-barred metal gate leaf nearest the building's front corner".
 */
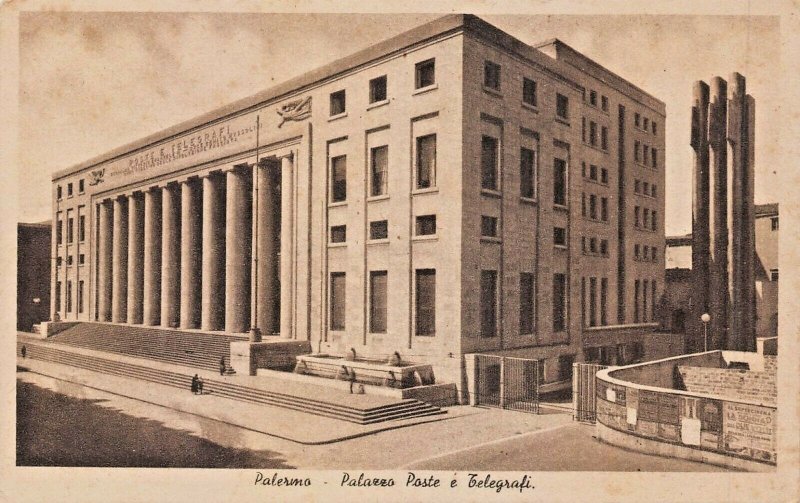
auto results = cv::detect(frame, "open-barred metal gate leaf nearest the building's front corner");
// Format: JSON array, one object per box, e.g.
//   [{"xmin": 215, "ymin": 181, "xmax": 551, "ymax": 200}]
[{"xmin": 475, "ymin": 355, "xmax": 540, "ymax": 414}]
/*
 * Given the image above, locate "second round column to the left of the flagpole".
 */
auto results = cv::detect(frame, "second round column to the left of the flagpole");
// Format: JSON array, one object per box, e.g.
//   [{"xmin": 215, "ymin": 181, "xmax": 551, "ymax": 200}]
[{"xmin": 200, "ymin": 174, "xmax": 225, "ymax": 330}]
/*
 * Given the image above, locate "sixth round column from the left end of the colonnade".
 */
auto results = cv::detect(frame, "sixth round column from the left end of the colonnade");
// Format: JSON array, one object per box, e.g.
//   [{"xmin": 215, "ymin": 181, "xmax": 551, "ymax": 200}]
[{"xmin": 180, "ymin": 179, "xmax": 202, "ymax": 328}]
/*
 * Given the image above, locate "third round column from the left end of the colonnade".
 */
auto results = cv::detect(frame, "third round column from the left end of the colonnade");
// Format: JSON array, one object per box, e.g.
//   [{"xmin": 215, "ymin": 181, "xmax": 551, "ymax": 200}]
[{"xmin": 128, "ymin": 193, "xmax": 144, "ymax": 323}]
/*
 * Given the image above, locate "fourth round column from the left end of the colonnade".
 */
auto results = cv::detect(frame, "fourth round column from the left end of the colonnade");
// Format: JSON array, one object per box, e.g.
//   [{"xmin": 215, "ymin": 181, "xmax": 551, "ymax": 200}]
[{"xmin": 143, "ymin": 189, "xmax": 161, "ymax": 325}]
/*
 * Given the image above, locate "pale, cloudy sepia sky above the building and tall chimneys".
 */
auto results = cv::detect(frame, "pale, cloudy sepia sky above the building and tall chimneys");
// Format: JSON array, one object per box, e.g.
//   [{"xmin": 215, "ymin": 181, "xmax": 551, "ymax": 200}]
[{"xmin": 18, "ymin": 12, "xmax": 781, "ymax": 235}]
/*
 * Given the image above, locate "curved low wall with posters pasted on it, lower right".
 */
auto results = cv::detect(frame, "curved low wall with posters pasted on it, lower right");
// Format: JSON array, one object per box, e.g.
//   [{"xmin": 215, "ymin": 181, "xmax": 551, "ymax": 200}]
[{"xmin": 597, "ymin": 351, "xmax": 777, "ymax": 471}]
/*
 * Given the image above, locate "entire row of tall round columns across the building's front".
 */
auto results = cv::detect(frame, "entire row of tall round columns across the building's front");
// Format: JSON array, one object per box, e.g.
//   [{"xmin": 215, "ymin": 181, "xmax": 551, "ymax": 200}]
[{"xmin": 96, "ymin": 155, "xmax": 294, "ymax": 337}]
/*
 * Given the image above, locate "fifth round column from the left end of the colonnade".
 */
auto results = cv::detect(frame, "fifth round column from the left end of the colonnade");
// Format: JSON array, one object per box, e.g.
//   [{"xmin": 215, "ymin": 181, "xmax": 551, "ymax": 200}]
[{"xmin": 161, "ymin": 183, "xmax": 181, "ymax": 328}]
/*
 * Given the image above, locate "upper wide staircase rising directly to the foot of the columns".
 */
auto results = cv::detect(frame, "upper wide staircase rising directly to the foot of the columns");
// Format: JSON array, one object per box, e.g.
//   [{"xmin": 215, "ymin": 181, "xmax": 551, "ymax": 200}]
[{"xmin": 47, "ymin": 323, "xmax": 241, "ymax": 371}]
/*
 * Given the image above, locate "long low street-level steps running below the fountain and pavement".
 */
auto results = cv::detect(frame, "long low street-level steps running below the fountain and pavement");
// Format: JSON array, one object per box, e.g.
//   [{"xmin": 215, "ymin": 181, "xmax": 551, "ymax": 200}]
[{"xmin": 17, "ymin": 339, "xmax": 445, "ymax": 425}]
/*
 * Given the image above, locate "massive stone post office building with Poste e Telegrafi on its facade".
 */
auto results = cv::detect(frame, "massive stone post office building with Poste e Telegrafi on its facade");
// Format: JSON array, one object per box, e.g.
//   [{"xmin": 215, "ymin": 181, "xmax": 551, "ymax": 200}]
[{"xmin": 51, "ymin": 15, "xmax": 665, "ymax": 400}]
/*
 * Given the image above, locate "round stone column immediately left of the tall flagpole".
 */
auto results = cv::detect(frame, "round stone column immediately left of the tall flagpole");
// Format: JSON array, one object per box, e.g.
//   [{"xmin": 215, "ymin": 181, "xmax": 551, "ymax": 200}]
[{"xmin": 225, "ymin": 167, "xmax": 253, "ymax": 333}]
